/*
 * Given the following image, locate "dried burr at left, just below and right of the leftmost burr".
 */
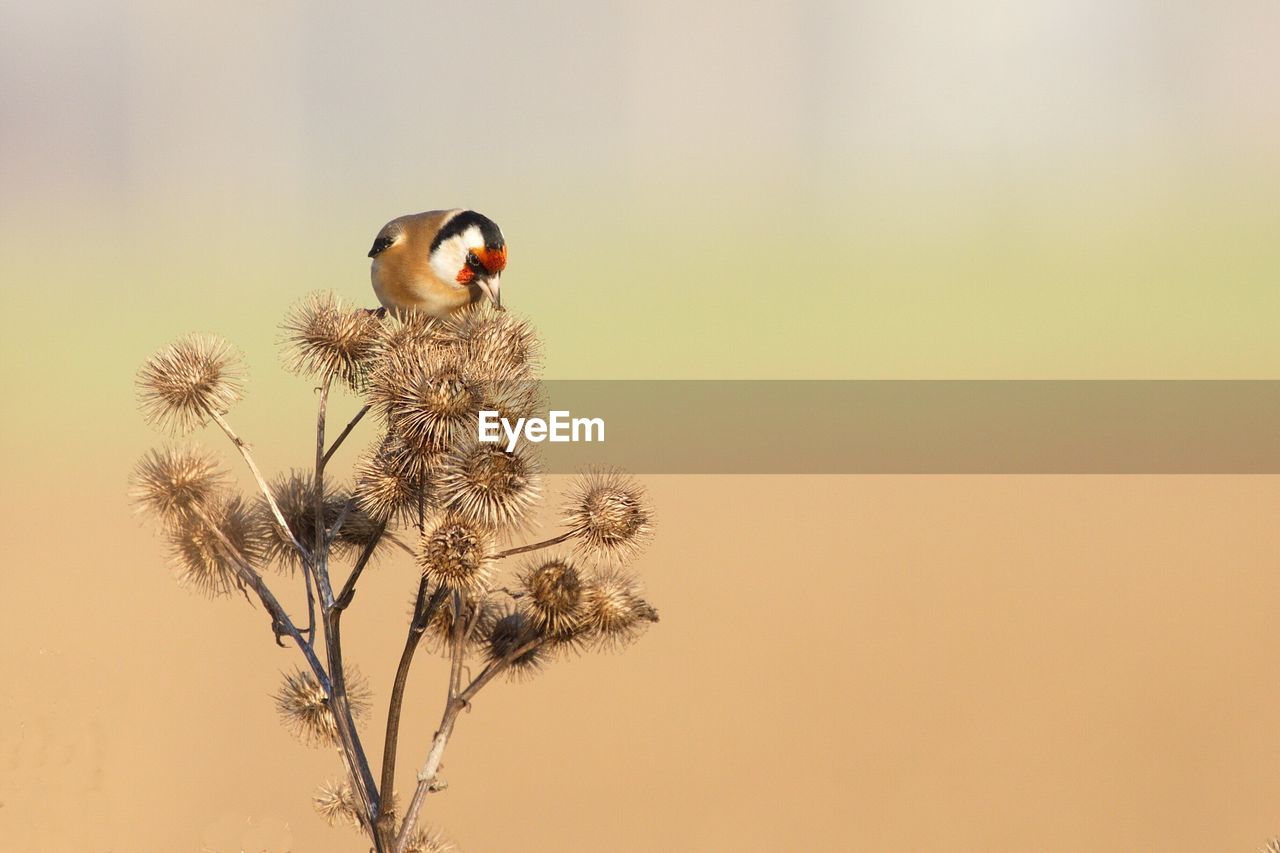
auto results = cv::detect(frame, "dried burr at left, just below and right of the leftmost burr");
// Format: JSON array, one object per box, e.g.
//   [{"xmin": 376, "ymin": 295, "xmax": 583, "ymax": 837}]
[{"xmin": 169, "ymin": 496, "xmax": 262, "ymax": 598}]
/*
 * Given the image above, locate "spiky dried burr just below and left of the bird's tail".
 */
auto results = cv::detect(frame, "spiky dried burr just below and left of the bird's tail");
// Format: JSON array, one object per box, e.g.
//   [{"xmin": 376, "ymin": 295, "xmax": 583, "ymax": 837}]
[{"xmin": 280, "ymin": 292, "xmax": 381, "ymax": 391}]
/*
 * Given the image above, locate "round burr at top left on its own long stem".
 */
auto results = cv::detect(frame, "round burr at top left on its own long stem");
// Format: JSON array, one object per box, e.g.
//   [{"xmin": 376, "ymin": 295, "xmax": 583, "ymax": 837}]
[{"xmin": 136, "ymin": 334, "xmax": 244, "ymax": 435}]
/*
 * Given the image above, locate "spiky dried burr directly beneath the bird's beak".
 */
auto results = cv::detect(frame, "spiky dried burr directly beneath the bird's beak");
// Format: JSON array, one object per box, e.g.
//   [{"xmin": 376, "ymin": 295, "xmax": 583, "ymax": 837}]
[{"xmin": 439, "ymin": 302, "xmax": 541, "ymax": 379}]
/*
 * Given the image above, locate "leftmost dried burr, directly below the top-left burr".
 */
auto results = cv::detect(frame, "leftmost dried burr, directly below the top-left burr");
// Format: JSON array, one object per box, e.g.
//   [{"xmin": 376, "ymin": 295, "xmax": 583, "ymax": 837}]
[{"xmin": 129, "ymin": 447, "xmax": 227, "ymax": 525}]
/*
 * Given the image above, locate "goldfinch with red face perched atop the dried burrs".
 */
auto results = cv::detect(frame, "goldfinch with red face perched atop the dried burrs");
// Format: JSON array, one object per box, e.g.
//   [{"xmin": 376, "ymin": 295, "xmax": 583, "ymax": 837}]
[{"xmin": 369, "ymin": 209, "xmax": 507, "ymax": 319}]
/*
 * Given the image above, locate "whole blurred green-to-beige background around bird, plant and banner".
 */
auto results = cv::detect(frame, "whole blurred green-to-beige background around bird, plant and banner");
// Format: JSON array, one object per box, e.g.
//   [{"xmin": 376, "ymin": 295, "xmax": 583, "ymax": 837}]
[{"xmin": 0, "ymin": 0, "xmax": 1280, "ymax": 853}]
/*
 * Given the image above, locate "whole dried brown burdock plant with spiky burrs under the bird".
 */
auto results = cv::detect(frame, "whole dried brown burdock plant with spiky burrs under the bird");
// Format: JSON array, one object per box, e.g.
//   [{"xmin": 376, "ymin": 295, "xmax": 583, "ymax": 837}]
[{"xmin": 131, "ymin": 295, "xmax": 658, "ymax": 853}]
